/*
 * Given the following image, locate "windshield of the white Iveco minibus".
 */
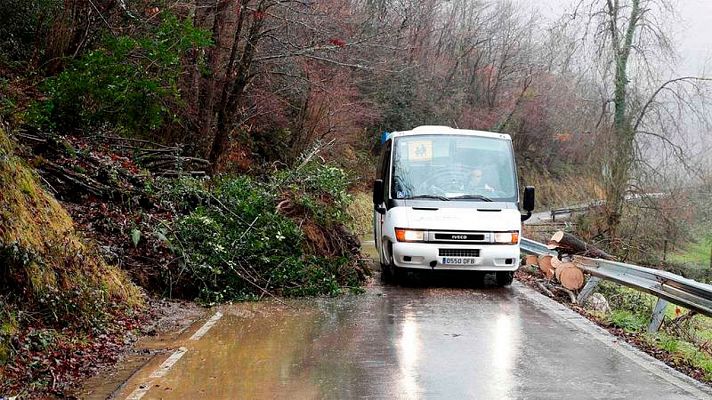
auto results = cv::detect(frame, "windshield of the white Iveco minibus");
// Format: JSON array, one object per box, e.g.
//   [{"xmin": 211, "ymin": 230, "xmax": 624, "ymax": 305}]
[{"xmin": 390, "ymin": 135, "xmax": 517, "ymax": 202}]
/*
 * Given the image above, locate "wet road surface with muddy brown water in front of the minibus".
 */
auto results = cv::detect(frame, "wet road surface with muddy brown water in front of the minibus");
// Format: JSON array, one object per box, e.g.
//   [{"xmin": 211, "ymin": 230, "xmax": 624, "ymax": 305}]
[{"xmin": 108, "ymin": 276, "xmax": 707, "ymax": 399}]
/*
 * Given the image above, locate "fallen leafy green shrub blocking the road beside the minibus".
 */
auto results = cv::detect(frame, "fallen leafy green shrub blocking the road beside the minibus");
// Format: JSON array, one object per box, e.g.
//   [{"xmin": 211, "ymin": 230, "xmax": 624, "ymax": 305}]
[{"xmin": 166, "ymin": 163, "xmax": 363, "ymax": 303}]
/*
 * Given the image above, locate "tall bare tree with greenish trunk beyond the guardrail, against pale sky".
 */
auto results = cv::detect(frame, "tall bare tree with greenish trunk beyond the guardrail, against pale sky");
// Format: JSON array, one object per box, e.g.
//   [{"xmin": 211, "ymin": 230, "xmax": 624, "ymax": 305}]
[{"xmin": 569, "ymin": 0, "xmax": 708, "ymax": 237}]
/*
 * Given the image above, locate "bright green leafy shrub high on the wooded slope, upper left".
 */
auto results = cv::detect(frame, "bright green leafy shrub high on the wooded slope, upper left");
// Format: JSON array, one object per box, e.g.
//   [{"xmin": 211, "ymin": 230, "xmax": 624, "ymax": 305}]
[{"xmin": 28, "ymin": 13, "xmax": 210, "ymax": 135}]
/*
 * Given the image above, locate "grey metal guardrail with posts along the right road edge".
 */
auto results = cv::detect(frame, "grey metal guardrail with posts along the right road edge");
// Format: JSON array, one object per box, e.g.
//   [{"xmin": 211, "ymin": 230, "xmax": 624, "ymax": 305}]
[{"xmin": 520, "ymin": 238, "xmax": 712, "ymax": 332}]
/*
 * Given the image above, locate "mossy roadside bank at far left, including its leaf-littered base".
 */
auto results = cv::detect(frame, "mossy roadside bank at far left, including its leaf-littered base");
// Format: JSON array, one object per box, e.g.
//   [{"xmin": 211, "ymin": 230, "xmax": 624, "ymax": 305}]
[{"xmin": 0, "ymin": 129, "xmax": 144, "ymax": 394}]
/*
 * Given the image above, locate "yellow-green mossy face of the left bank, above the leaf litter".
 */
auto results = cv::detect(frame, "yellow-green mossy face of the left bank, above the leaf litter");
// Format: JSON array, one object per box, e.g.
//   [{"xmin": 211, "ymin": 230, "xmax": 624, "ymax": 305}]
[{"xmin": 0, "ymin": 130, "xmax": 143, "ymax": 326}]
